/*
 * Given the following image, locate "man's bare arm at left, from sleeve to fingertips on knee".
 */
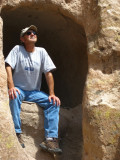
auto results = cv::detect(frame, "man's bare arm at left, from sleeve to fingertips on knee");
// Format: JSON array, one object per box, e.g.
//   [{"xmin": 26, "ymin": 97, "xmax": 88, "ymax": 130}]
[{"xmin": 5, "ymin": 63, "xmax": 20, "ymax": 99}]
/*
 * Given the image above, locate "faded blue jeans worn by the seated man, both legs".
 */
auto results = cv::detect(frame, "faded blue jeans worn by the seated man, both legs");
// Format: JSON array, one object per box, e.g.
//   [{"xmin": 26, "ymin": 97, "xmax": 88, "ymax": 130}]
[{"xmin": 10, "ymin": 87, "xmax": 60, "ymax": 138}]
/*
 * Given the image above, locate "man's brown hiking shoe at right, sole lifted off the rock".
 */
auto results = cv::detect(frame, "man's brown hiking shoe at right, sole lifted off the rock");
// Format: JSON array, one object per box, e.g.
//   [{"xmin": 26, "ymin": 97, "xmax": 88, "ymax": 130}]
[{"xmin": 40, "ymin": 138, "xmax": 62, "ymax": 153}]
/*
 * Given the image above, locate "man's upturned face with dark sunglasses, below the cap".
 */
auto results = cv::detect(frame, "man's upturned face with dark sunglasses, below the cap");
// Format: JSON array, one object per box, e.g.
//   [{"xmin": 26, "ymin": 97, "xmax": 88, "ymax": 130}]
[{"xmin": 20, "ymin": 30, "xmax": 37, "ymax": 45}]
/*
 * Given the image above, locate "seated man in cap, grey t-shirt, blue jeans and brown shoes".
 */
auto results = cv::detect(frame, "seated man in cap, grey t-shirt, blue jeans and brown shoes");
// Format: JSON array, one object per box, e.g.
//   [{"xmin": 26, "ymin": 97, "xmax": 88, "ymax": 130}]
[{"xmin": 5, "ymin": 25, "xmax": 62, "ymax": 153}]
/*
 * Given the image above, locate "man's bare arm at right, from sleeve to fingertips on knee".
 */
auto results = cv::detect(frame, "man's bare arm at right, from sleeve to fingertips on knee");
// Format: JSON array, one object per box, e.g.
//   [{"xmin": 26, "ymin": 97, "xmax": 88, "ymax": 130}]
[{"xmin": 45, "ymin": 72, "xmax": 61, "ymax": 106}]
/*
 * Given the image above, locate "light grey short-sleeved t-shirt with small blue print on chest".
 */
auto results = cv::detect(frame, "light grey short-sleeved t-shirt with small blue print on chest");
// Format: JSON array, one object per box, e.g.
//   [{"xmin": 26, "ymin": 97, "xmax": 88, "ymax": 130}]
[{"xmin": 5, "ymin": 45, "xmax": 56, "ymax": 91}]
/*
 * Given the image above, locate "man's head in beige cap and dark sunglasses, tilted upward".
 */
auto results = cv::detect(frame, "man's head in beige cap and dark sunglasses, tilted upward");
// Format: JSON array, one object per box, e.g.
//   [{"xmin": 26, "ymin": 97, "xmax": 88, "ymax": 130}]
[{"xmin": 20, "ymin": 25, "xmax": 37, "ymax": 45}]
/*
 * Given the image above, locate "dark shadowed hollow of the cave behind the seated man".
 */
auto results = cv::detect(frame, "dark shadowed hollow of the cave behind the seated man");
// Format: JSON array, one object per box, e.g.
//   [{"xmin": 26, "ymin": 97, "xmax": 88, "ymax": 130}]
[{"xmin": 1, "ymin": 6, "xmax": 88, "ymax": 108}]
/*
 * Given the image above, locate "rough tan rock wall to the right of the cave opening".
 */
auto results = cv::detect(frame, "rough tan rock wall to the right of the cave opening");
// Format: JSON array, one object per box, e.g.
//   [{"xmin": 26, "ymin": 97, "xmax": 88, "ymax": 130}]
[{"xmin": 83, "ymin": 1, "xmax": 120, "ymax": 160}]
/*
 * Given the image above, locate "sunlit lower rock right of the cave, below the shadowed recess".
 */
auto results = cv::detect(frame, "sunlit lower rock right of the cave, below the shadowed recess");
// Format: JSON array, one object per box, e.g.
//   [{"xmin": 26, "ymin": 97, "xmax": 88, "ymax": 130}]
[{"xmin": 83, "ymin": 69, "xmax": 120, "ymax": 160}]
